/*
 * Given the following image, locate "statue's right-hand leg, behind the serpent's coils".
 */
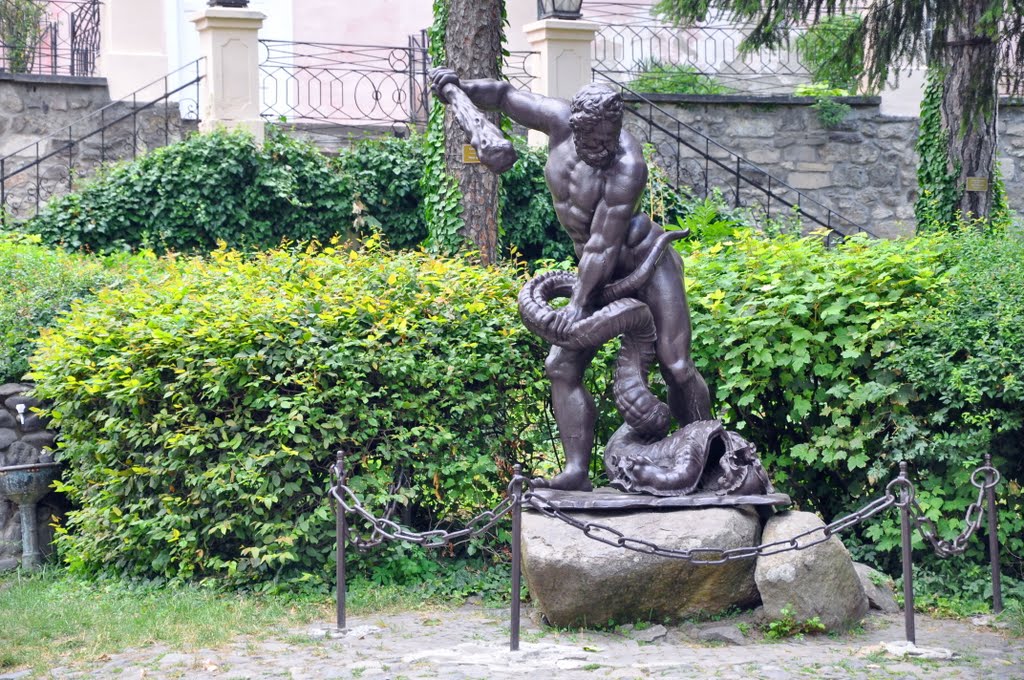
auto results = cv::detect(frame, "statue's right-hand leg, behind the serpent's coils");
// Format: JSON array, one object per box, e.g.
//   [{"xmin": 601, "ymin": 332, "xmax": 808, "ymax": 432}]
[{"xmin": 640, "ymin": 248, "xmax": 711, "ymax": 427}]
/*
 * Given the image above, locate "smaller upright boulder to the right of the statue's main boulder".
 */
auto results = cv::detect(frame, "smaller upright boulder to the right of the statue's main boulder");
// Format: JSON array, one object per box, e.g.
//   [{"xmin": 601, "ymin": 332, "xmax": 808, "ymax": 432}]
[{"xmin": 754, "ymin": 512, "xmax": 868, "ymax": 631}]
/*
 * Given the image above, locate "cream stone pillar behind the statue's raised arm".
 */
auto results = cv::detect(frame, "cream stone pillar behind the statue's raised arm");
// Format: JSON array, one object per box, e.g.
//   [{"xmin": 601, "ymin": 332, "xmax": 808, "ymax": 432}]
[{"xmin": 522, "ymin": 18, "xmax": 599, "ymax": 146}]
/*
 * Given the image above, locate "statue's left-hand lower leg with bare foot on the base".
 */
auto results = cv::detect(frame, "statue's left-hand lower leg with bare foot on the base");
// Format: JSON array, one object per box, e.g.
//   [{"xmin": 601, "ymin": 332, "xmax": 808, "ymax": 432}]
[{"xmin": 538, "ymin": 346, "xmax": 597, "ymax": 492}]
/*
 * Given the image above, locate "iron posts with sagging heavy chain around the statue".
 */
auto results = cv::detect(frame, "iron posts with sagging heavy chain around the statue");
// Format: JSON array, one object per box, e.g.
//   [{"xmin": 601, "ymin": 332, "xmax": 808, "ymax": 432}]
[{"xmin": 329, "ymin": 452, "xmax": 1002, "ymax": 651}]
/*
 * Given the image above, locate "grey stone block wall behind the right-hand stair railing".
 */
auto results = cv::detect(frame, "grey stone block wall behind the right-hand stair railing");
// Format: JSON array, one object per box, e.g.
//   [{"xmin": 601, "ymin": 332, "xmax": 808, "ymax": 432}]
[{"xmin": 627, "ymin": 95, "xmax": 1024, "ymax": 237}]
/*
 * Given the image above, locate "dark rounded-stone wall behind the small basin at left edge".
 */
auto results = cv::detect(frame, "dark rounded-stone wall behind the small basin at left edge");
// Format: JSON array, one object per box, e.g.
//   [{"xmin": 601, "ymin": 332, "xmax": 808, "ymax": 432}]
[{"xmin": 0, "ymin": 383, "xmax": 62, "ymax": 570}]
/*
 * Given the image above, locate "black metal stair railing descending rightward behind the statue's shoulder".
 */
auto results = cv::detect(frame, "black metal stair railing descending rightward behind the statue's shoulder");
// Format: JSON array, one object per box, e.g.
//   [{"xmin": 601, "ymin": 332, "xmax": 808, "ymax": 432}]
[{"xmin": 594, "ymin": 71, "xmax": 878, "ymax": 241}]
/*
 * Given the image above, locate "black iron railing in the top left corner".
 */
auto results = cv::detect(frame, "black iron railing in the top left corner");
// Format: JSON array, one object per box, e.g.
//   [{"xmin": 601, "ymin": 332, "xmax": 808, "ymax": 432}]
[{"xmin": 0, "ymin": 0, "xmax": 100, "ymax": 77}]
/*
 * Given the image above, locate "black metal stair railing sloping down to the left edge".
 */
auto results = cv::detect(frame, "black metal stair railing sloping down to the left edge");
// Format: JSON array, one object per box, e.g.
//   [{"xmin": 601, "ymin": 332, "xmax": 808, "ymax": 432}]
[{"xmin": 0, "ymin": 58, "xmax": 205, "ymax": 219}]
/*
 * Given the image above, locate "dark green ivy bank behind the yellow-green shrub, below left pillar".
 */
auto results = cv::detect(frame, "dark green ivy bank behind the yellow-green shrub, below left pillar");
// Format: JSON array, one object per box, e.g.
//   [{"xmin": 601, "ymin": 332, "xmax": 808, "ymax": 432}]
[{"xmin": 22, "ymin": 125, "xmax": 571, "ymax": 260}]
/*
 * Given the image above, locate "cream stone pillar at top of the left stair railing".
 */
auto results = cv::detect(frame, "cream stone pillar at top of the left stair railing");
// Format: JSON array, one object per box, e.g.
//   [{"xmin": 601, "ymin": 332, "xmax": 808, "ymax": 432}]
[{"xmin": 190, "ymin": 7, "xmax": 266, "ymax": 143}]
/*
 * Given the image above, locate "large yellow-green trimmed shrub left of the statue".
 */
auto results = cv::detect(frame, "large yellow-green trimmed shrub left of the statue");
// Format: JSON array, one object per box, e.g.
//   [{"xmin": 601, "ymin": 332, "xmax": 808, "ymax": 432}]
[{"xmin": 32, "ymin": 241, "xmax": 548, "ymax": 587}]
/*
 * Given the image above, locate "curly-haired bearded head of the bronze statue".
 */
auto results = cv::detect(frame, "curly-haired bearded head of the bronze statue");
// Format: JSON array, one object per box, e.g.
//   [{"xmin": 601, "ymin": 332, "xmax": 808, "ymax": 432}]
[{"xmin": 569, "ymin": 84, "xmax": 623, "ymax": 168}]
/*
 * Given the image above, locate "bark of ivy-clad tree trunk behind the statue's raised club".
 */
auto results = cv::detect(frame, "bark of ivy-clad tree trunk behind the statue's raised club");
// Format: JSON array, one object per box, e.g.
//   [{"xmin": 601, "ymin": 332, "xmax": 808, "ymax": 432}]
[{"xmin": 444, "ymin": 0, "xmax": 503, "ymax": 264}]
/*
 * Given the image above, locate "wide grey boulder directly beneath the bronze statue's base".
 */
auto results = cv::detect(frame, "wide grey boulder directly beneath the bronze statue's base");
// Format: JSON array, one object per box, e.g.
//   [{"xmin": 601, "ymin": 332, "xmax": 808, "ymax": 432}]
[{"xmin": 522, "ymin": 507, "xmax": 761, "ymax": 627}]
